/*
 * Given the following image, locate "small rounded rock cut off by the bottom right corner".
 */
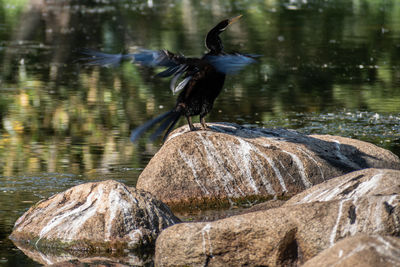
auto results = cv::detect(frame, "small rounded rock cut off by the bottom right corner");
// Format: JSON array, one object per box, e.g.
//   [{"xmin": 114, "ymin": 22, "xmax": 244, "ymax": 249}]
[{"xmin": 303, "ymin": 235, "xmax": 400, "ymax": 267}]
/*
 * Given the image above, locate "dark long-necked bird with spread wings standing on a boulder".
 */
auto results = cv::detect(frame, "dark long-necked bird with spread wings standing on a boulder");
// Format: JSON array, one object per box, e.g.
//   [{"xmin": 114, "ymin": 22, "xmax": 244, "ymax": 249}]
[{"xmin": 82, "ymin": 15, "xmax": 259, "ymax": 143}]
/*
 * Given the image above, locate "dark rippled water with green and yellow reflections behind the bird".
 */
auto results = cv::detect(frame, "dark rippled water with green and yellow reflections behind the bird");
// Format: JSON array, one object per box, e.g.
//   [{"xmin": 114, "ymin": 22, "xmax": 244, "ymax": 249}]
[{"xmin": 0, "ymin": 0, "xmax": 400, "ymax": 266}]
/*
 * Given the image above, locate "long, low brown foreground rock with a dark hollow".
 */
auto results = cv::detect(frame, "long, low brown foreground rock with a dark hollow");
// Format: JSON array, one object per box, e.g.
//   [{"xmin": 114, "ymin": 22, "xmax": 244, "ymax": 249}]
[{"xmin": 155, "ymin": 195, "xmax": 400, "ymax": 266}]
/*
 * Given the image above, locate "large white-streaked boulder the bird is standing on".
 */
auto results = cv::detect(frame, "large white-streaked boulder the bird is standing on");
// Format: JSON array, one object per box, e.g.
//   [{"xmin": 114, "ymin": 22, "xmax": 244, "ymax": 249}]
[{"xmin": 137, "ymin": 123, "xmax": 400, "ymax": 207}]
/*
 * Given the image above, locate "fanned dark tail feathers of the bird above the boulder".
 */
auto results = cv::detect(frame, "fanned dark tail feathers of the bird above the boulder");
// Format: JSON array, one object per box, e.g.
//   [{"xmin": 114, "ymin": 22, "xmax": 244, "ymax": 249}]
[{"xmin": 130, "ymin": 110, "xmax": 181, "ymax": 143}]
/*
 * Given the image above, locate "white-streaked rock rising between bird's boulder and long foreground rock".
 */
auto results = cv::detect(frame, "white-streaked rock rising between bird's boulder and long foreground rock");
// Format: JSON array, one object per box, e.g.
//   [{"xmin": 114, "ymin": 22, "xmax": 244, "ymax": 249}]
[{"xmin": 285, "ymin": 168, "xmax": 400, "ymax": 205}]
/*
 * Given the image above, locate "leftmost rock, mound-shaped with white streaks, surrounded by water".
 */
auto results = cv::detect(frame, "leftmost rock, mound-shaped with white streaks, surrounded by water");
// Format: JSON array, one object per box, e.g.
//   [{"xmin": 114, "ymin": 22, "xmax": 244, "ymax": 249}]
[{"xmin": 10, "ymin": 180, "xmax": 179, "ymax": 251}]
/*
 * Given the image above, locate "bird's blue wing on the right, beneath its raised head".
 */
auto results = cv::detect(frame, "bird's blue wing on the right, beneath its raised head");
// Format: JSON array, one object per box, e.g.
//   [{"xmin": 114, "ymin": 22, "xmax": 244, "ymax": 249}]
[{"xmin": 205, "ymin": 53, "xmax": 259, "ymax": 74}]
